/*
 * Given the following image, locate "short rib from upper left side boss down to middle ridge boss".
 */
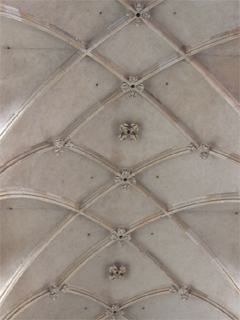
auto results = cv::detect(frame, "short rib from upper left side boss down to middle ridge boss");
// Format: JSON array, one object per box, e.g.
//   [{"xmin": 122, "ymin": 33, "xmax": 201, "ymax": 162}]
[{"xmin": 69, "ymin": 143, "xmax": 119, "ymax": 174}]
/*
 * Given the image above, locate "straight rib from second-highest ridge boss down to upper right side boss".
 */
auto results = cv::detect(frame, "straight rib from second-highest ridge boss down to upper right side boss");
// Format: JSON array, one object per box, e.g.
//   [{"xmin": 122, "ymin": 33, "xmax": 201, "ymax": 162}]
[{"xmin": 138, "ymin": 90, "xmax": 201, "ymax": 146}]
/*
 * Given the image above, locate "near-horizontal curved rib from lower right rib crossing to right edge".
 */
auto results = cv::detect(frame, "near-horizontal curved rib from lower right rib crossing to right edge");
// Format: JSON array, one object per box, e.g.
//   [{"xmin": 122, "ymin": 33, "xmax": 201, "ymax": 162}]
[{"xmin": 168, "ymin": 192, "xmax": 240, "ymax": 214}]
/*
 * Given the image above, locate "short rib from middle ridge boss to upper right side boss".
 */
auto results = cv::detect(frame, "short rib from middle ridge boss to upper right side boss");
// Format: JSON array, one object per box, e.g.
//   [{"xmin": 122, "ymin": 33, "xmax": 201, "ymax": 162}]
[{"xmin": 133, "ymin": 146, "xmax": 190, "ymax": 174}]
